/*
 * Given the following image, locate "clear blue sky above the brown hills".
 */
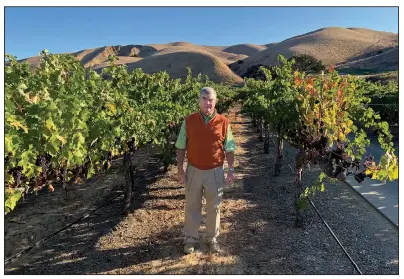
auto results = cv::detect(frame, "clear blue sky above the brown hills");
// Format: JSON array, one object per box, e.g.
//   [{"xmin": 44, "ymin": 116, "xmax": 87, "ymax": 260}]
[{"xmin": 5, "ymin": 7, "xmax": 398, "ymax": 59}]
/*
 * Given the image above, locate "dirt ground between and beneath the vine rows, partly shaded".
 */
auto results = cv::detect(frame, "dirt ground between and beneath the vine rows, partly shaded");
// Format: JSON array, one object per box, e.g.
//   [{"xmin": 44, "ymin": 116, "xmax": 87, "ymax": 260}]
[{"xmin": 5, "ymin": 107, "xmax": 398, "ymax": 274}]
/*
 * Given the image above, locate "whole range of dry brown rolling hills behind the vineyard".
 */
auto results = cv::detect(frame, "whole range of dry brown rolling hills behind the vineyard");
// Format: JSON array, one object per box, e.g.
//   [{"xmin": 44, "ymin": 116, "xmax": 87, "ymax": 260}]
[{"xmin": 20, "ymin": 27, "xmax": 398, "ymax": 84}]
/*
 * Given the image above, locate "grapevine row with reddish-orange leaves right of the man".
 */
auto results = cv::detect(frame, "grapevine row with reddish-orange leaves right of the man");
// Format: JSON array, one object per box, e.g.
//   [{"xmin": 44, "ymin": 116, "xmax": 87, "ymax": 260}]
[{"xmin": 243, "ymin": 56, "xmax": 398, "ymax": 229}]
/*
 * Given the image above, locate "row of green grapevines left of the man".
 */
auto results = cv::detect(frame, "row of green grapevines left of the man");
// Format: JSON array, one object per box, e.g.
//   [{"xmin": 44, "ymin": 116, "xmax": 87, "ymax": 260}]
[{"xmin": 5, "ymin": 50, "xmax": 234, "ymax": 212}]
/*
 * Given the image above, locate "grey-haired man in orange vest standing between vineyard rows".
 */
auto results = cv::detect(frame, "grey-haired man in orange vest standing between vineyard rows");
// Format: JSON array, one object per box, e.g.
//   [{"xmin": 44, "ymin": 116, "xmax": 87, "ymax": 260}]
[{"xmin": 175, "ymin": 87, "xmax": 236, "ymax": 254}]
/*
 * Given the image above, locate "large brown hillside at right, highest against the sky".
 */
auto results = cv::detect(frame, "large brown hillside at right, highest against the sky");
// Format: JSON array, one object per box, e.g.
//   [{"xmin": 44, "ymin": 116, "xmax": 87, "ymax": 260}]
[{"xmin": 233, "ymin": 27, "xmax": 397, "ymax": 75}]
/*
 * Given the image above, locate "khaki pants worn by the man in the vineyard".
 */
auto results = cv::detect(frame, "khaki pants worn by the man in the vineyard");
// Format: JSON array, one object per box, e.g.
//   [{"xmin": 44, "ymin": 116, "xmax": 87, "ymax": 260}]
[{"xmin": 184, "ymin": 164, "xmax": 225, "ymax": 243}]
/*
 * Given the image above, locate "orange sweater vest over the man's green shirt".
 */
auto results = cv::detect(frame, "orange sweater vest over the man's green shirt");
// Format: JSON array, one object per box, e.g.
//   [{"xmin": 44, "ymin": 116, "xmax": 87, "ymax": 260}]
[{"xmin": 185, "ymin": 112, "xmax": 229, "ymax": 170}]
